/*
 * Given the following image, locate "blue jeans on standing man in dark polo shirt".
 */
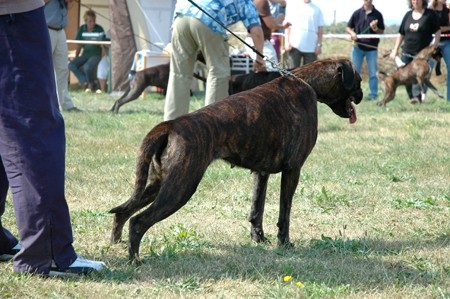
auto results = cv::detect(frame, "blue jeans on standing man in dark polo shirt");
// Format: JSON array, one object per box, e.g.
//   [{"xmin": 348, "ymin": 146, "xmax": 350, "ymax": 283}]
[{"xmin": 352, "ymin": 47, "xmax": 378, "ymax": 99}]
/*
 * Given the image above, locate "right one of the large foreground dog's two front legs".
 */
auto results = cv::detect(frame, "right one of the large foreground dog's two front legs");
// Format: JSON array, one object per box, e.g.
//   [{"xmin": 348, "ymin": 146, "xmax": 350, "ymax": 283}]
[{"xmin": 277, "ymin": 167, "xmax": 300, "ymax": 247}]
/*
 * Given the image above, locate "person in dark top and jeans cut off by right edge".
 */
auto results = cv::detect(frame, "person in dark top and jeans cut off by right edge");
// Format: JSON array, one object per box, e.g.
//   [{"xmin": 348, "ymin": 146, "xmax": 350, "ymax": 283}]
[{"xmin": 430, "ymin": 0, "xmax": 450, "ymax": 101}]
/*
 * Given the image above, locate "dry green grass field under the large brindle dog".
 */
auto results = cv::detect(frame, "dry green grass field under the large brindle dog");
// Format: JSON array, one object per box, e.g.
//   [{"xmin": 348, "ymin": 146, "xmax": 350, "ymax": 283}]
[{"xmin": 0, "ymin": 39, "xmax": 450, "ymax": 298}]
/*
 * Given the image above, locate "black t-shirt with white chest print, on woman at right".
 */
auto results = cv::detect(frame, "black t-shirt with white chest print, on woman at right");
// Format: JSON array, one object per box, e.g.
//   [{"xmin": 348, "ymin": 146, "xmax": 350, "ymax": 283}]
[{"xmin": 398, "ymin": 8, "xmax": 440, "ymax": 55}]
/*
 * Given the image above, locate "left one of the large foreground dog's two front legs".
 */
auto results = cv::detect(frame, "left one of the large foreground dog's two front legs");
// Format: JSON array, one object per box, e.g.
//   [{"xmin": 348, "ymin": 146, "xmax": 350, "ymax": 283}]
[{"xmin": 249, "ymin": 172, "xmax": 269, "ymax": 243}]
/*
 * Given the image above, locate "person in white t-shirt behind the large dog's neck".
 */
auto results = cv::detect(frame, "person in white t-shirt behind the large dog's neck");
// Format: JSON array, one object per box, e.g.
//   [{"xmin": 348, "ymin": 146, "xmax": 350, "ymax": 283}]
[{"xmin": 284, "ymin": 0, "xmax": 325, "ymax": 68}]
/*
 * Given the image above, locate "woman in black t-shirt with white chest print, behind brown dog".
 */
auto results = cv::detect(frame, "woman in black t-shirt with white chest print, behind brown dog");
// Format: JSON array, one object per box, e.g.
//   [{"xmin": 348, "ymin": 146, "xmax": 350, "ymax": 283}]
[{"xmin": 390, "ymin": 0, "xmax": 441, "ymax": 104}]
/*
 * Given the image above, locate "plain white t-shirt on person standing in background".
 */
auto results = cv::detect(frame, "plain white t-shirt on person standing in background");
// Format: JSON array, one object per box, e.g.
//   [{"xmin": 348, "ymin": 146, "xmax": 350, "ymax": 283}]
[{"xmin": 285, "ymin": 0, "xmax": 325, "ymax": 53}]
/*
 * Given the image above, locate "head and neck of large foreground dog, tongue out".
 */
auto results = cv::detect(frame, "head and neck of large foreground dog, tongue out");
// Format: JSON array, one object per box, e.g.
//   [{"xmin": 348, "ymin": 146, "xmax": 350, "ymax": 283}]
[{"xmin": 292, "ymin": 59, "xmax": 363, "ymax": 123}]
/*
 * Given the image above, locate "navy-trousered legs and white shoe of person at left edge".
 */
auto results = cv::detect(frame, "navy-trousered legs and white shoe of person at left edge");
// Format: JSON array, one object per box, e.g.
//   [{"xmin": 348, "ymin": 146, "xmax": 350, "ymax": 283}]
[{"xmin": 0, "ymin": 0, "xmax": 104, "ymax": 275}]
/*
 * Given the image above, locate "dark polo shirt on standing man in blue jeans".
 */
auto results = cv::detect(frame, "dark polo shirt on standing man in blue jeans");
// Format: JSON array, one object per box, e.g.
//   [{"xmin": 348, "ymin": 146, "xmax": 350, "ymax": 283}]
[{"xmin": 347, "ymin": 6, "xmax": 384, "ymax": 51}]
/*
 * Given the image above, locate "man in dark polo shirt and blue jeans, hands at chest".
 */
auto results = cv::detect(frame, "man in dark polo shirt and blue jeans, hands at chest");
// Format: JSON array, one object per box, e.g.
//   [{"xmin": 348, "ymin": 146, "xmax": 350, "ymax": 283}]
[{"xmin": 345, "ymin": 0, "xmax": 385, "ymax": 101}]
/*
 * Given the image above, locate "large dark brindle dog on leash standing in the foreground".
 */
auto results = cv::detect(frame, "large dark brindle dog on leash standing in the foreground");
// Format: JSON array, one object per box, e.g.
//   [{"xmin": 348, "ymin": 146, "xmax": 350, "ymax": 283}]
[{"xmin": 110, "ymin": 59, "xmax": 363, "ymax": 263}]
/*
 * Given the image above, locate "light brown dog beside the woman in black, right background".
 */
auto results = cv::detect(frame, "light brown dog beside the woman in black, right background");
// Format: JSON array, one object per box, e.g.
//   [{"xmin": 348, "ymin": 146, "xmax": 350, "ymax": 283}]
[{"xmin": 377, "ymin": 46, "xmax": 444, "ymax": 107}]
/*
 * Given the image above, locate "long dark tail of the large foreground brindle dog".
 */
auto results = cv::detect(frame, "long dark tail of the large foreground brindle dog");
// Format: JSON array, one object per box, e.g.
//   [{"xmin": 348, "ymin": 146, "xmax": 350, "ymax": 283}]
[{"xmin": 109, "ymin": 122, "xmax": 171, "ymax": 213}]
